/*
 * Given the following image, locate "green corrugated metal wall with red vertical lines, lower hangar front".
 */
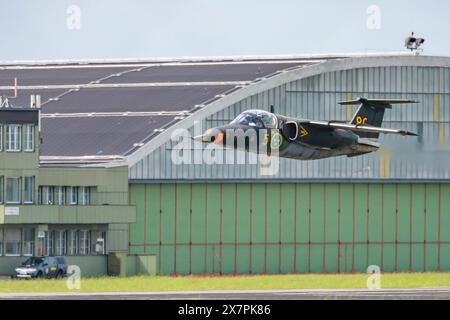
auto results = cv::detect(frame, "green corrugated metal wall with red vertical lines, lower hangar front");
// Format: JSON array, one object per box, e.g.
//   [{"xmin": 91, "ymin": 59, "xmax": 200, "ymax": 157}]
[{"xmin": 130, "ymin": 183, "xmax": 450, "ymax": 274}]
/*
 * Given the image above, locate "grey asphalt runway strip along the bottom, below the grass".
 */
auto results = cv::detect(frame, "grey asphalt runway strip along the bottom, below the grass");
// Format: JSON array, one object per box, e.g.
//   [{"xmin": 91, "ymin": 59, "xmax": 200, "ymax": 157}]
[{"xmin": 0, "ymin": 288, "xmax": 450, "ymax": 300}]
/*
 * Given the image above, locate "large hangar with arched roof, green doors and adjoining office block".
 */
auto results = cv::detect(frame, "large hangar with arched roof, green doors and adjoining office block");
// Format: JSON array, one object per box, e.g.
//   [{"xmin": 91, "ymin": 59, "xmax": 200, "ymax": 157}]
[{"xmin": 0, "ymin": 53, "xmax": 450, "ymax": 275}]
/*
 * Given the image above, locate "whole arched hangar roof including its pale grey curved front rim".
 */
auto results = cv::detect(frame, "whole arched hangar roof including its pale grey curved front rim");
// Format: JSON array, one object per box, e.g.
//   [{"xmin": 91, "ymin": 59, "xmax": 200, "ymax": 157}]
[{"xmin": 0, "ymin": 54, "xmax": 450, "ymax": 166}]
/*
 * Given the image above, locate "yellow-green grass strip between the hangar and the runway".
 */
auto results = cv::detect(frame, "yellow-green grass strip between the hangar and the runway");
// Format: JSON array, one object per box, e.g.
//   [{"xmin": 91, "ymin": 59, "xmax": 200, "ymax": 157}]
[{"xmin": 0, "ymin": 273, "xmax": 450, "ymax": 293}]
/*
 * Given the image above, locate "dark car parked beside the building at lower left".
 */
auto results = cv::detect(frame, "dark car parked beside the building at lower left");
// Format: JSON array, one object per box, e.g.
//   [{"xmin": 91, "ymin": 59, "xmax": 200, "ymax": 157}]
[{"xmin": 13, "ymin": 257, "xmax": 67, "ymax": 278}]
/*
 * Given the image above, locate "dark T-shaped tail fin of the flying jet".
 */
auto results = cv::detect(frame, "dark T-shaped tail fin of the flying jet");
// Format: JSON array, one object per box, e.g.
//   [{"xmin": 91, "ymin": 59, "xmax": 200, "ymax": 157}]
[{"xmin": 338, "ymin": 98, "xmax": 417, "ymax": 139}]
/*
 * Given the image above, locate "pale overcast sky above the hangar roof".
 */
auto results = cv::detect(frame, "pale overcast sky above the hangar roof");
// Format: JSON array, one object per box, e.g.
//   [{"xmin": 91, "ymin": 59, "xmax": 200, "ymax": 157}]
[{"xmin": 0, "ymin": 0, "xmax": 450, "ymax": 60}]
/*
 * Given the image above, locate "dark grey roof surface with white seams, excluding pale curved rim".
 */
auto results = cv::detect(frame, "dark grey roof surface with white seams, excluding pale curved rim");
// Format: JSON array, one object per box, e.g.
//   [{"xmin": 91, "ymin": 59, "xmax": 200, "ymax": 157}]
[{"xmin": 0, "ymin": 56, "xmax": 336, "ymax": 162}]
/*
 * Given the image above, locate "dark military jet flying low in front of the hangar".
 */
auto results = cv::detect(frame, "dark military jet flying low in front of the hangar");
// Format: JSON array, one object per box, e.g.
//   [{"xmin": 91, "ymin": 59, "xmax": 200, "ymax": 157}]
[{"xmin": 193, "ymin": 98, "xmax": 417, "ymax": 160}]
